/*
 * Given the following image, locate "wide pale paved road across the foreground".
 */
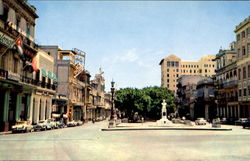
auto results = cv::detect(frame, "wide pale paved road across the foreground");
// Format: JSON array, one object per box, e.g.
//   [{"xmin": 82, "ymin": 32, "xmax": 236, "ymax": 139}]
[{"xmin": 0, "ymin": 121, "xmax": 250, "ymax": 161}]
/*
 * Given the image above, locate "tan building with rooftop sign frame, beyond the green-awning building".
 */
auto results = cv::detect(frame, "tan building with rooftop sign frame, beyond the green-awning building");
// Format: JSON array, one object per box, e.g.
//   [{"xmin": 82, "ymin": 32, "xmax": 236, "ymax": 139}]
[{"xmin": 40, "ymin": 46, "xmax": 89, "ymax": 122}]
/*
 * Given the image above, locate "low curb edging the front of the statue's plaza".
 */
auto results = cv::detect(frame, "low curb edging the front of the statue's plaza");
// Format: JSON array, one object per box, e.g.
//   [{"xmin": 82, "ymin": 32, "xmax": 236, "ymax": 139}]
[{"xmin": 101, "ymin": 128, "xmax": 232, "ymax": 131}]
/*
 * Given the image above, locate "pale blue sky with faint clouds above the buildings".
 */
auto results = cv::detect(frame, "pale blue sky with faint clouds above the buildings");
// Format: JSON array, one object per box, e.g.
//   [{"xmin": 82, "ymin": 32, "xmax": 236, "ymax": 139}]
[{"xmin": 29, "ymin": 0, "xmax": 250, "ymax": 91}]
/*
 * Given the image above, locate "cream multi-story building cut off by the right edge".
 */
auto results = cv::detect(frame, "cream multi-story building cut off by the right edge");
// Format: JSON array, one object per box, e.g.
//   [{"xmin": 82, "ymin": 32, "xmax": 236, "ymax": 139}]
[{"xmin": 234, "ymin": 17, "xmax": 250, "ymax": 117}]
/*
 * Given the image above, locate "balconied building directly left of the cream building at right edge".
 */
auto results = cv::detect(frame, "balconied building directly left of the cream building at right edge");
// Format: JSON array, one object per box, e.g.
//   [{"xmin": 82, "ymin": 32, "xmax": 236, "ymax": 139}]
[{"xmin": 214, "ymin": 45, "xmax": 240, "ymax": 119}]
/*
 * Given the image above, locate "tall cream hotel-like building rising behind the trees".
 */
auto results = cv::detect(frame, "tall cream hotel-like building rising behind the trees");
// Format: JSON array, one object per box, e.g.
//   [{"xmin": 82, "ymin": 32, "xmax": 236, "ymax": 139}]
[{"xmin": 159, "ymin": 55, "xmax": 216, "ymax": 93}]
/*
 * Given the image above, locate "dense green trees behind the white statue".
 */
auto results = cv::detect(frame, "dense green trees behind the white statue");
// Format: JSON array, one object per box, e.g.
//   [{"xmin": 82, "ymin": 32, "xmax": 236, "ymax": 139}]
[{"xmin": 115, "ymin": 86, "xmax": 175, "ymax": 119}]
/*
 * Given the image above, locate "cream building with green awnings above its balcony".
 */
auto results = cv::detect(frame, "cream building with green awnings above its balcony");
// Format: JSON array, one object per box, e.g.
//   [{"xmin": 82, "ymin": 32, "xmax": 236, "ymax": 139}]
[{"xmin": 30, "ymin": 49, "xmax": 57, "ymax": 123}]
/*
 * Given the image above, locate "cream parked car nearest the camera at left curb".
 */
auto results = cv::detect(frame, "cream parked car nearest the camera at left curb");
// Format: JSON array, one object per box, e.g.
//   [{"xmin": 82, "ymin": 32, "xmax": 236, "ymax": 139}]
[{"xmin": 11, "ymin": 121, "xmax": 34, "ymax": 133}]
